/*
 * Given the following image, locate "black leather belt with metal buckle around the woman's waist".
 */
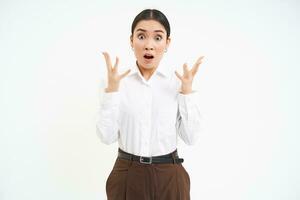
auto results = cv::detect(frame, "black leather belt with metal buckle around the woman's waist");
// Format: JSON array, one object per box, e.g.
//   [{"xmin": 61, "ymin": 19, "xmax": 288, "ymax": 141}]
[{"xmin": 118, "ymin": 148, "xmax": 183, "ymax": 164}]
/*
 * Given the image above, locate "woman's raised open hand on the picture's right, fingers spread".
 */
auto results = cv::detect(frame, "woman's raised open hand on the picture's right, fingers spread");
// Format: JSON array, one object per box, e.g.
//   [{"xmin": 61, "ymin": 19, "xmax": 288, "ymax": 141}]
[{"xmin": 175, "ymin": 56, "xmax": 204, "ymax": 94}]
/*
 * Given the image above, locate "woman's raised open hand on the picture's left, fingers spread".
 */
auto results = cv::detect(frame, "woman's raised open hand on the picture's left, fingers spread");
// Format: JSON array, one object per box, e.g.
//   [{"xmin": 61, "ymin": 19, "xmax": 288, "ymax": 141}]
[{"xmin": 102, "ymin": 52, "xmax": 130, "ymax": 92}]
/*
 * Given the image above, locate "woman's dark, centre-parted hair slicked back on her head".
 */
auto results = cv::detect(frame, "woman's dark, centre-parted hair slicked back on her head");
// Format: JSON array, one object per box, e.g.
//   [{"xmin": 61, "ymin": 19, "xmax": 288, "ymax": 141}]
[{"xmin": 131, "ymin": 9, "xmax": 171, "ymax": 38}]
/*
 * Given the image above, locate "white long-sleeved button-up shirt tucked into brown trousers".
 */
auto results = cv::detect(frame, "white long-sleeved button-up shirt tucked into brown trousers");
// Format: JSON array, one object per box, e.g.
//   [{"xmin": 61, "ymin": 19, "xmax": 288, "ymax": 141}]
[{"xmin": 96, "ymin": 61, "xmax": 204, "ymax": 157}]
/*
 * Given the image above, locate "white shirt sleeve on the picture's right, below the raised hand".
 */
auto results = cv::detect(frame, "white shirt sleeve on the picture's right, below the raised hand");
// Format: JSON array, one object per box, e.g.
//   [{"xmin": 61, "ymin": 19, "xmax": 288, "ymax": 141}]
[{"xmin": 176, "ymin": 91, "xmax": 205, "ymax": 145}]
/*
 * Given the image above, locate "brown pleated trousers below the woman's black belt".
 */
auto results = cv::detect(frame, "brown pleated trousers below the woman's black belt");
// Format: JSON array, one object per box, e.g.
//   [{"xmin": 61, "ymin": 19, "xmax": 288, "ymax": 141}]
[{"xmin": 106, "ymin": 155, "xmax": 190, "ymax": 200}]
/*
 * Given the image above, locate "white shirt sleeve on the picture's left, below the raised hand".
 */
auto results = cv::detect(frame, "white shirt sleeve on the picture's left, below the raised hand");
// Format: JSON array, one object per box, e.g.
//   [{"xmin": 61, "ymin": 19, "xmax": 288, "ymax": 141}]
[{"xmin": 96, "ymin": 89, "xmax": 120, "ymax": 144}]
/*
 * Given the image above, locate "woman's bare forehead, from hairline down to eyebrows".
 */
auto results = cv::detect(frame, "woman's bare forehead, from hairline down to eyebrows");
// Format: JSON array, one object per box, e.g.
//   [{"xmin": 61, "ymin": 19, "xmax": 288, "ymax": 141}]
[{"xmin": 134, "ymin": 20, "xmax": 166, "ymax": 33}]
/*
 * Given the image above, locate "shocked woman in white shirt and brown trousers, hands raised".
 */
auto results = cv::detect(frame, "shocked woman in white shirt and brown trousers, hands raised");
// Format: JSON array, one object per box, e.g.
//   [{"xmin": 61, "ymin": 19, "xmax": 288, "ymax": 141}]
[{"xmin": 97, "ymin": 9, "xmax": 203, "ymax": 200}]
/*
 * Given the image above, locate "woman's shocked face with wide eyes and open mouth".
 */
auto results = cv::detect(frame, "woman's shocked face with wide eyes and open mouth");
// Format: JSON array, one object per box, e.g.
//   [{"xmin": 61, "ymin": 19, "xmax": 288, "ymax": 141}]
[{"xmin": 130, "ymin": 20, "xmax": 170, "ymax": 69}]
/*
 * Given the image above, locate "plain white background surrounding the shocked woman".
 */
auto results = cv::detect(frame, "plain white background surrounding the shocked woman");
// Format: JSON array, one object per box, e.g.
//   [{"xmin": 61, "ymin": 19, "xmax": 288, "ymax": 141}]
[{"xmin": 0, "ymin": 0, "xmax": 300, "ymax": 200}]
